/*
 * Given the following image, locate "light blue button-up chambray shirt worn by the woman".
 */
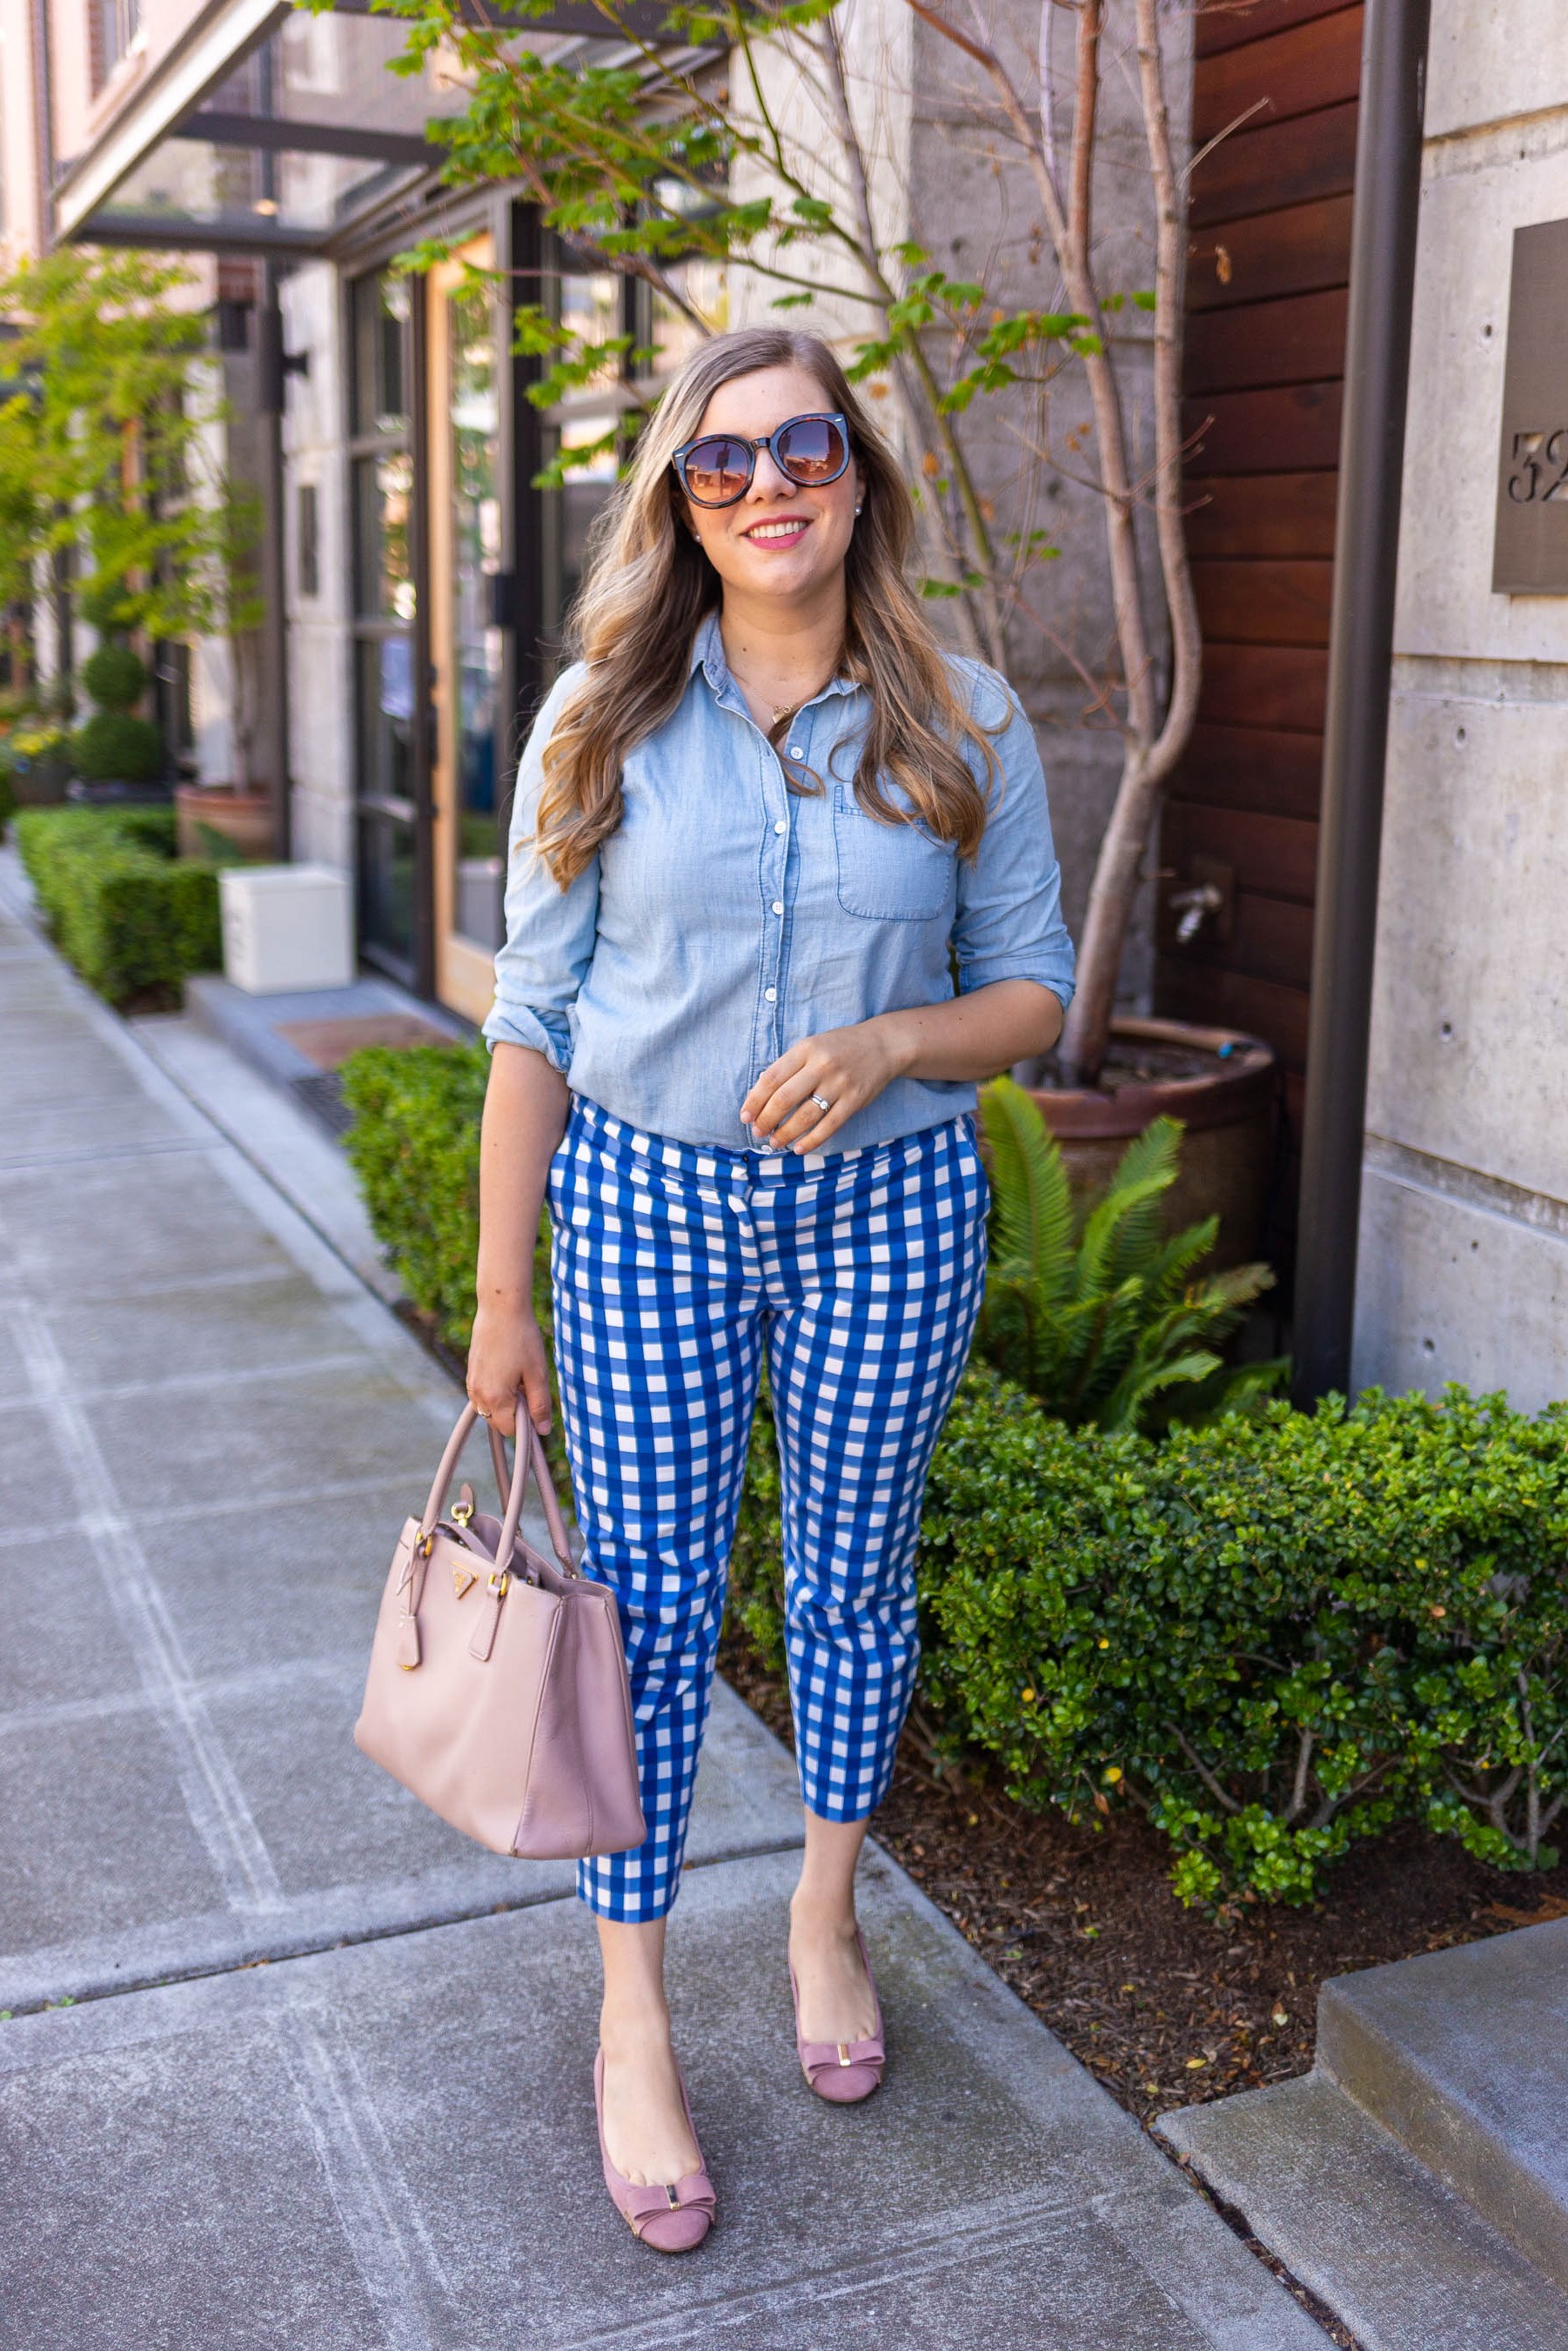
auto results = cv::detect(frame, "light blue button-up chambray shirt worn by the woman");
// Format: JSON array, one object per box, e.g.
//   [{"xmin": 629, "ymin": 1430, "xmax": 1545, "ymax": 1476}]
[{"xmin": 485, "ymin": 613, "xmax": 1072, "ymax": 1152}]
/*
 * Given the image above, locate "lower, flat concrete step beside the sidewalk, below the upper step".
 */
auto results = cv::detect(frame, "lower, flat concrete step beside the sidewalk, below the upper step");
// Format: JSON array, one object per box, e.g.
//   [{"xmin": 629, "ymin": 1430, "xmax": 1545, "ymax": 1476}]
[{"xmin": 1159, "ymin": 2071, "xmax": 1568, "ymax": 2351}]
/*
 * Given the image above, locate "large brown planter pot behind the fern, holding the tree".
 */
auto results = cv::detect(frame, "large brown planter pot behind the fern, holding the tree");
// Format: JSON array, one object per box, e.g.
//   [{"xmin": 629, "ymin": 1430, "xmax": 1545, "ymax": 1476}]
[{"xmin": 1029, "ymin": 1021, "xmax": 1274, "ymax": 1269}]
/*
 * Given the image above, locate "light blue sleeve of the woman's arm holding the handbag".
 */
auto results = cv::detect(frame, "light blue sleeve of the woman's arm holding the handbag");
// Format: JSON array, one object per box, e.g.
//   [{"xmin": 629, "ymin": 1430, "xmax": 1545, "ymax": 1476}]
[{"xmin": 485, "ymin": 663, "xmax": 600, "ymax": 1077}]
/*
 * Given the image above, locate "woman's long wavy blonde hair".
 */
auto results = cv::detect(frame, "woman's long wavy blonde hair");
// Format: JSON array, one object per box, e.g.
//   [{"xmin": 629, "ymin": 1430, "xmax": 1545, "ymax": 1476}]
[{"xmin": 533, "ymin": 327, "xmax": 996, "ymax": 888}]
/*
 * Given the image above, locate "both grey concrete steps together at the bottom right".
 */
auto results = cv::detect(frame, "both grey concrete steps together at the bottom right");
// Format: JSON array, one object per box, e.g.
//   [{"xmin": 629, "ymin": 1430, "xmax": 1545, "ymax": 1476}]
[{"xmin": 1159, "ymin": 1921, "xmax": 1568, "ymax": 2351}]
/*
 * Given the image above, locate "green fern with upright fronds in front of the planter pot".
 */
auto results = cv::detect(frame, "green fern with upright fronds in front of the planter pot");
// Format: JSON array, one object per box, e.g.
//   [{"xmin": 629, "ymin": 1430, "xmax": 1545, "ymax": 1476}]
[{"xmin": 978, "ymin": 1077, "xmax": 1286, "ymax": 1430}]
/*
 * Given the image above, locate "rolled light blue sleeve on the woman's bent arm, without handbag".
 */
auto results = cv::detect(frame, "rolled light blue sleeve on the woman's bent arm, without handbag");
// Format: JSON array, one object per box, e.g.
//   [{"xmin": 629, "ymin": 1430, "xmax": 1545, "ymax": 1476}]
[{"xmin": 952, "ymin": 663, "xmax": 1075, "ymax": 1011}]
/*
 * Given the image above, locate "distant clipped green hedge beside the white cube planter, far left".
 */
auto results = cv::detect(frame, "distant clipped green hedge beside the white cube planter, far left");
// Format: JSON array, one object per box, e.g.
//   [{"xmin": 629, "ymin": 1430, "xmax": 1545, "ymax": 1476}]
[{"xmin": 17, "ymin": 808, "xmax": 224, "ymax": 1004}]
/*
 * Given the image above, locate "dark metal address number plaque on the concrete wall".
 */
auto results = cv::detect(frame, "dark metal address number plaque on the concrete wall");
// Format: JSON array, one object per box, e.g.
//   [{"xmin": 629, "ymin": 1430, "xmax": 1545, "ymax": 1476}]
[{"xmin": 1493, "ymin": 221, "xmax": 1568, "ymax": 595}]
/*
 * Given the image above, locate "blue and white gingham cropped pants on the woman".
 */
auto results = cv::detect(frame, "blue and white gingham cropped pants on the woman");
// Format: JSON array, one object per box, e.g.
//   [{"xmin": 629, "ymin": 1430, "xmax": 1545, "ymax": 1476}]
[{"xmin": 550, "ymin": 1098, "xmax": 988, "ymax": 1921}]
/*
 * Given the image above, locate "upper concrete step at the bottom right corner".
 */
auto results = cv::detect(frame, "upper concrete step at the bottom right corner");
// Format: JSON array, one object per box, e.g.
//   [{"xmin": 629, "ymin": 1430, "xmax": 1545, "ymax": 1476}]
[{"xmin": 1317, "ymin": 1919, "xmax": 1568, "ymax": 2294}]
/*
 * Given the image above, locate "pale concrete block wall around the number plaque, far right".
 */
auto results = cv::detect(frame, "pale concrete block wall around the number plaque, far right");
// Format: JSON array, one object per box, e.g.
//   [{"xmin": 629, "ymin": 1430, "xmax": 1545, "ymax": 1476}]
[{"xmin": 1357, "ymin": 0, "xmax": 1568, "ymax": 1406}]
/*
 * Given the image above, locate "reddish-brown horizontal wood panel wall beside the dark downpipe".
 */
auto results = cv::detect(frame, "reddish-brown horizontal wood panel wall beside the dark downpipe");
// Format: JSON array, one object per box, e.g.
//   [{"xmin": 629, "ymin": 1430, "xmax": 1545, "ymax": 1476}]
[{"xmin": 1155, "ymin": 0, "xmax": 1361, "ymax": 1239}]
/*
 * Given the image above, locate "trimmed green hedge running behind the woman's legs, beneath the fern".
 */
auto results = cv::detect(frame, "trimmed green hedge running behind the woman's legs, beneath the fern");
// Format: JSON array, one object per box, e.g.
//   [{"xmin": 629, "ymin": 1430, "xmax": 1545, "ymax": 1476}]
[{"xmin": 345, "ymin": 1048, "xmax": 1568, "ymax": 1902}]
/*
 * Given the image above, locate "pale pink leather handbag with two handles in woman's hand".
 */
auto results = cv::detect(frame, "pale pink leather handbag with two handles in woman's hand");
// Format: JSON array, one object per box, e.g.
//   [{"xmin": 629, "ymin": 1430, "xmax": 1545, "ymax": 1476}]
[{"xmin": 355, "ymin": 1403, "xmax": 647, "ymax": 1862}]
